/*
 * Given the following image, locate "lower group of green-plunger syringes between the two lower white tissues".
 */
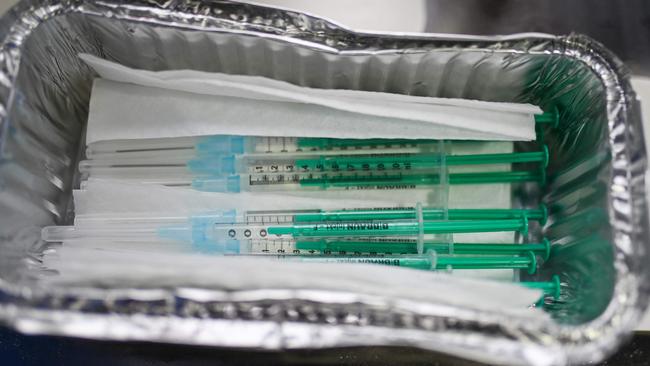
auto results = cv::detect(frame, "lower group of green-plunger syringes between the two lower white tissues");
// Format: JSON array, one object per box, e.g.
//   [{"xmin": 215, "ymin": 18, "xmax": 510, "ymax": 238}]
[{"xmin": 43, "ymin": 205, "xmax": 557, "ymax": 302}]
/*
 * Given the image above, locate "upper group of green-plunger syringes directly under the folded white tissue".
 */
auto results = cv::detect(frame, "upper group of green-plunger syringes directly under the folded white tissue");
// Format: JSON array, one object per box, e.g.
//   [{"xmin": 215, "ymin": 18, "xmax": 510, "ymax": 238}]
[{"xmin": 79, "ymin": 136, "xmax": 548, "ymax": 192}]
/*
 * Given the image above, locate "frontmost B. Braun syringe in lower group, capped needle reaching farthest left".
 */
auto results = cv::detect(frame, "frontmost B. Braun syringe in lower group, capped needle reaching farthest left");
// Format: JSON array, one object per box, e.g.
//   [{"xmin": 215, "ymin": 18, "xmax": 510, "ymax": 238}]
[{"xmin": 42, "ymin": 214, "xmax": 528, "ymax": 249}]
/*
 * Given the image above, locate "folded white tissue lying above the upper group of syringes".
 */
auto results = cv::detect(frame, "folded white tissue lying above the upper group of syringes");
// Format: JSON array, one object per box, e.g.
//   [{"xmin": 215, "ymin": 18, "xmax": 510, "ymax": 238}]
[{"xmin": 81, "ymin": 55, "xmax": 542, "ymax": 144}]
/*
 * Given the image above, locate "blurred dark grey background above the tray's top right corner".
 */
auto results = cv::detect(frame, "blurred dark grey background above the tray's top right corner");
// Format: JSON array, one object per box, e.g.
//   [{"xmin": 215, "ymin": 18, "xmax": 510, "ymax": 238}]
[{"xmin": 426, "ymin": 0, "xmax": 650, "ymax": 76}]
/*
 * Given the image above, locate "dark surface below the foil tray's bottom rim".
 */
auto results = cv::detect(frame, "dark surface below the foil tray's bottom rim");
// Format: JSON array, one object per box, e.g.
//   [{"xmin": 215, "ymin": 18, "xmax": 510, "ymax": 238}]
[{"xmin": 0, "ymin": 328, "xmax": 650, "ymax": 366}]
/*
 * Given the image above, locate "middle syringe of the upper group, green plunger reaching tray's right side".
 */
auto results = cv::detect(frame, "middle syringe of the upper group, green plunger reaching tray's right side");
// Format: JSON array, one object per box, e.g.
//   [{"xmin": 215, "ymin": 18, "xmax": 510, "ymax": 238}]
[{"xmin": 79, "ymin": 146, "xmax": 548, "ymax": 176}]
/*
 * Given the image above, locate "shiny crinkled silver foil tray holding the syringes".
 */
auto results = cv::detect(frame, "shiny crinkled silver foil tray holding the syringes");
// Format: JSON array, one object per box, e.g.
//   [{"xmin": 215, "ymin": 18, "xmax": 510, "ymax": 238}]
[{"xmin": 0, "ymin": 0, "xmax": 650, "ymax": 365}]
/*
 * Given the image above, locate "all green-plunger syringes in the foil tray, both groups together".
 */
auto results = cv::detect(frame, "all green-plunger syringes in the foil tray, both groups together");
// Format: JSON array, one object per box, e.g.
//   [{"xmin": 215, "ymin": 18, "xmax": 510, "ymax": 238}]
[{"xmin": 43, "ymin": 101, "xmax": 559, "ymax": 302}]
